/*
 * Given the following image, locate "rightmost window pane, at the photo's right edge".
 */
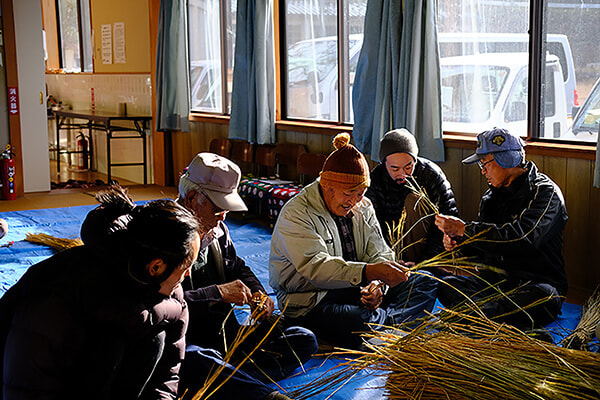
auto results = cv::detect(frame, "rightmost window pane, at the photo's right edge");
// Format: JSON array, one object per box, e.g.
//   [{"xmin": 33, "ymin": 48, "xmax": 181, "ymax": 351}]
[{"xmin": 541, "ymin": 0, "xmax": 600, "ymax": 143}]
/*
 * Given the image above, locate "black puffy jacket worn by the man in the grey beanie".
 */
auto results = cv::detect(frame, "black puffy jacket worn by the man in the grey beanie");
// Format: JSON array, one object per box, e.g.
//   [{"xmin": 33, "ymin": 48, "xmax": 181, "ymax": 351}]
[{"xmin": 366, "ymin": 157, "xmax": 458, "ymax": 262}]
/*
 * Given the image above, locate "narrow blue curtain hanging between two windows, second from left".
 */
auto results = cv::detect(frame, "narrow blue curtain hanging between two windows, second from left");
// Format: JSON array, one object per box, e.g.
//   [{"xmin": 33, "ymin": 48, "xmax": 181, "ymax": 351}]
[{"xmin": 229, "ymin": 0, "xmax": 276, "ymax": 144}]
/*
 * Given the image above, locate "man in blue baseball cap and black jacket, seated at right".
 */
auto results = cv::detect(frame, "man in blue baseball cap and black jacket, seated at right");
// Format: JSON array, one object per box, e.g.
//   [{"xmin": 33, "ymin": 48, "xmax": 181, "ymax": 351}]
[{"xmin": 435, "ymin": 128, "xmax": 567, "ymax": 330}]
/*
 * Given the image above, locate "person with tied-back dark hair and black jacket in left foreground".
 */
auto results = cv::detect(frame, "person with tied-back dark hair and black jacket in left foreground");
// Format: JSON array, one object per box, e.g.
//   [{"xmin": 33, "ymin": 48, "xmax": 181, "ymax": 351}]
[{"xmin": 0, "ymin": 188, "xmax": 200, "ymax": 400}]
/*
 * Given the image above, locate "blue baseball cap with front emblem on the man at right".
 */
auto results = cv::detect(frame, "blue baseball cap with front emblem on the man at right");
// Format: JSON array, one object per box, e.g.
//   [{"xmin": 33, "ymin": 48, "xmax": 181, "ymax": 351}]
[{"xmin": 462, "ymin": 128, "xmax": 525, "ymax": 168}]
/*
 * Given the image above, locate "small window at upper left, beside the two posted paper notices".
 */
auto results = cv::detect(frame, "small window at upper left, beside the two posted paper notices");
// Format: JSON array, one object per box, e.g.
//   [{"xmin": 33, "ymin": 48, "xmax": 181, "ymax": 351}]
[{"xmin": 57, "ymin": 0, "xmax": 93, "ymax": 72}]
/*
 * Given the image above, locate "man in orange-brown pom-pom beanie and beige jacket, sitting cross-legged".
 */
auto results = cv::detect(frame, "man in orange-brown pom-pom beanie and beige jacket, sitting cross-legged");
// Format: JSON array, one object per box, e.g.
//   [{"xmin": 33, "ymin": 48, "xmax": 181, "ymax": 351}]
[{"xmin": 269, "ymin": 133, "xmax": 437, "ymax": 348}]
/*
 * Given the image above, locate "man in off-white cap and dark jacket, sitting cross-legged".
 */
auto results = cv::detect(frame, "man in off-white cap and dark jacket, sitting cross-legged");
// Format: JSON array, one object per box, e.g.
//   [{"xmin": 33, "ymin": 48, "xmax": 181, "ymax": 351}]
[{"xmin": 178, "ymin": 153, "xmax": 317, "ymax": 400}]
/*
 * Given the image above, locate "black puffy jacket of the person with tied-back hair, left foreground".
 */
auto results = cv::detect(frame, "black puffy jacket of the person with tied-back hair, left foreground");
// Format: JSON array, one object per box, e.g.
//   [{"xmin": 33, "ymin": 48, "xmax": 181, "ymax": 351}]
[{"xmin": 0, "ymin": 245, "xmax": 188, "ymax": 400}]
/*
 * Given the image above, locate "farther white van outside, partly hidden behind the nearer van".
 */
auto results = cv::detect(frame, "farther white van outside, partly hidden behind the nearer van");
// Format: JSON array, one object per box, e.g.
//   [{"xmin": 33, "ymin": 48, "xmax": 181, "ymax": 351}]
[{"xmin": 438, "ymin": 33, "xmax": 579, "ymax": 116}]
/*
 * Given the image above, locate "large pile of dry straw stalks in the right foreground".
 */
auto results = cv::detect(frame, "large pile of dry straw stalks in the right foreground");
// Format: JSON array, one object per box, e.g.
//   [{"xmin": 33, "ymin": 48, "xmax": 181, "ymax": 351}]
[{"xmin": 293, "ymin": 311, "xmax": 600, "ymax": 400}]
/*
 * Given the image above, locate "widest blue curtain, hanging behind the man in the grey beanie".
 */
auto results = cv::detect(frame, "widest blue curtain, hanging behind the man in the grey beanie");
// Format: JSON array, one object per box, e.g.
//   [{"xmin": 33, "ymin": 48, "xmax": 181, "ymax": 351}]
[{"xmin": 352, "ymin": 0, "xmax": 444, "ymax": 161}]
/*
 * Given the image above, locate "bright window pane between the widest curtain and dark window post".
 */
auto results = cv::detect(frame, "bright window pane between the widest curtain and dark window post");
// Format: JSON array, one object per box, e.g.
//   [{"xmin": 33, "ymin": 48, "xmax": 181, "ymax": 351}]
[{"xmin": 438, "ymin": 0, "xmax": 529, "ymax": 136}]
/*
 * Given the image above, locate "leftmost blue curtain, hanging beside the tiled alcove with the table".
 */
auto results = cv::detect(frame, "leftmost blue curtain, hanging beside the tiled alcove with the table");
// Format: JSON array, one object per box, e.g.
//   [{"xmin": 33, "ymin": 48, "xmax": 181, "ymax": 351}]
[{"xmin": 156, "ymin": 0, "xmax": 190, "ymax": 132}]
